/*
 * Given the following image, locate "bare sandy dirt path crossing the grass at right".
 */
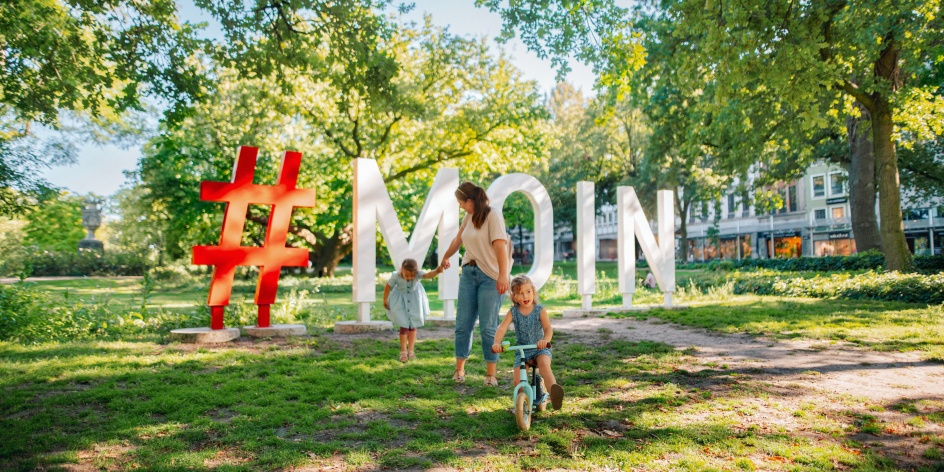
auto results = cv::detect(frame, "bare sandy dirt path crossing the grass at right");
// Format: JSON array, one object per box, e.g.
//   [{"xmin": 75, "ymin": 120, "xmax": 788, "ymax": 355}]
[{"xmin": 554, "ymin": 318, "xmax": 944, "ymax": 469}]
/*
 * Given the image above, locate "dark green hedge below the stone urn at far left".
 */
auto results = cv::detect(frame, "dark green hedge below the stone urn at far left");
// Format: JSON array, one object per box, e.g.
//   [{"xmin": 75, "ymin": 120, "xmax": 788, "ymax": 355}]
[{"xmin": 0, "ymin": 248, "xmax": 150, "ymax": 277}]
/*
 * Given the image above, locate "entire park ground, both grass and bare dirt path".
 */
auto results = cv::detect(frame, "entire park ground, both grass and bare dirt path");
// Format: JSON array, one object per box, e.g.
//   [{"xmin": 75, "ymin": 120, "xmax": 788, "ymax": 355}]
[{"xmin": 0, "ymin": 264, "xmax": 944, "ymax": 471}]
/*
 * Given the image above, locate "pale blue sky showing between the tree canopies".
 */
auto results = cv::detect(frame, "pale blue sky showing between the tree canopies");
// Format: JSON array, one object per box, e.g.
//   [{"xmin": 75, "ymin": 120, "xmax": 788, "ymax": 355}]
[{"xmin": 43, "ymin": 0, "xmax": 594, "ymax": 196}]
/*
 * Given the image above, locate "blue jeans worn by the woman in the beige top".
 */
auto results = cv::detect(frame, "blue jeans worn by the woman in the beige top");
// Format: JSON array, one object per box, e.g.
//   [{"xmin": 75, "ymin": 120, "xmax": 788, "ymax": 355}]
[{"xmin": 456, "ymin": 265, "xmax": 505, "ymax": 362}]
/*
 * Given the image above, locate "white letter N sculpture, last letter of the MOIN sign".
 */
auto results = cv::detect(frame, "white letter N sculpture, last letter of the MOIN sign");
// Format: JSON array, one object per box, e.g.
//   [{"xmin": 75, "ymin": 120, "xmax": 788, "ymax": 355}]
[{"xmin": 616, "ymin": 187, "xmax": 675, "ymax": 308}]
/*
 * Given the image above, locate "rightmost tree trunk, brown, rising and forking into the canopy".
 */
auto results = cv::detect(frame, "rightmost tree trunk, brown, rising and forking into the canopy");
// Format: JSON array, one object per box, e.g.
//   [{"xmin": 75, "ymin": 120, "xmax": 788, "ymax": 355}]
[{"xmin": 872, "ymin": 96, "xmax": 914, "ymax": 272}]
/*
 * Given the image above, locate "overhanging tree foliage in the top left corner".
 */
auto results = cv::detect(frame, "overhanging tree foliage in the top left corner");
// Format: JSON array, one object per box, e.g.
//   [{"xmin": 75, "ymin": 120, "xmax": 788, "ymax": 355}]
[{"xmin": 0, "ymin": 0, "xmax": 207, "ymax": 214}]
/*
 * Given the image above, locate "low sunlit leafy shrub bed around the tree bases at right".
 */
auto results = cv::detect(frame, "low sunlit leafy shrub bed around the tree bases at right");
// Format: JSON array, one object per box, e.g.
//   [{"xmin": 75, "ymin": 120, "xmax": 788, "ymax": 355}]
[{"xmin": 728, "ymin": 270, "xmax": 944, "ymax": 305}]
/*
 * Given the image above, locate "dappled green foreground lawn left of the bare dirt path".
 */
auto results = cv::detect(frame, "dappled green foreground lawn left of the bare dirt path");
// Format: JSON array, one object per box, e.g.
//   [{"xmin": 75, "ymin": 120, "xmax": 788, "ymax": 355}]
[{"xmin": 0, "ymin": 334, "xmax": 936, "ymax": 470}]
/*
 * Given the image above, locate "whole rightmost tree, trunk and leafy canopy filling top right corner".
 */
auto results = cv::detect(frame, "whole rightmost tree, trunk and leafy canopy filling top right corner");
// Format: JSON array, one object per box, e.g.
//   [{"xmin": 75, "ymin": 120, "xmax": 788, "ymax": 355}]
[{"xmin": 663, "ymin": 0, "xmax": 944, "ymax": 270}]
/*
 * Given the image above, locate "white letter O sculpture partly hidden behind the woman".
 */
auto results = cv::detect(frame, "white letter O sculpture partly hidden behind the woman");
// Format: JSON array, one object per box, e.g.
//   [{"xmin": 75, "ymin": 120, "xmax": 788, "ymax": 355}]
[{"xmin": 488, "ymin": 174, "xmax": 554, "ymax": 289}]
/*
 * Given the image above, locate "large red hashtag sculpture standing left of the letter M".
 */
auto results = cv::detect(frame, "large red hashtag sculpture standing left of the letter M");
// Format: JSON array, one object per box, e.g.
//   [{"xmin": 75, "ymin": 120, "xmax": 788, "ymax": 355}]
[{"xmin": 193, "ymin": 146, "xmax": 315, "ymax": 329}]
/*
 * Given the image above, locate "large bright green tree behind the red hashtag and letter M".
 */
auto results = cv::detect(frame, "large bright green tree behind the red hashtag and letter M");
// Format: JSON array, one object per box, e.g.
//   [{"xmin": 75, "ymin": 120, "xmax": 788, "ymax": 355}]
[{"xmin": 140, "ymin": 23, "xmax": 545, "ymax": 275}]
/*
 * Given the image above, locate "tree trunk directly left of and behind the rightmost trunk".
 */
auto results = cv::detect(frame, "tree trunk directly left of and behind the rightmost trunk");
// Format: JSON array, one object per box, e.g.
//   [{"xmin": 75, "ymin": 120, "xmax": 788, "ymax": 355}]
[{"xmin": 846, "ymin": 103, "xmax": 882, "ymax": 252}]
